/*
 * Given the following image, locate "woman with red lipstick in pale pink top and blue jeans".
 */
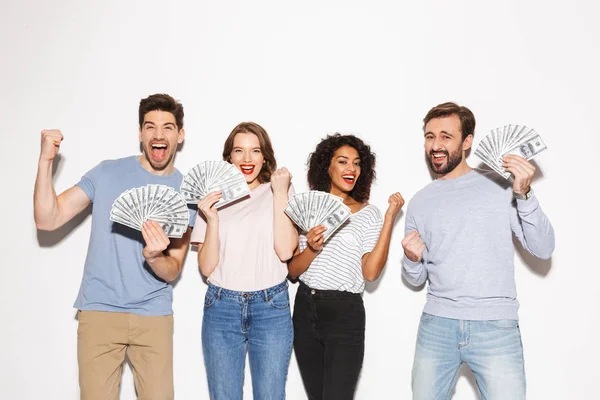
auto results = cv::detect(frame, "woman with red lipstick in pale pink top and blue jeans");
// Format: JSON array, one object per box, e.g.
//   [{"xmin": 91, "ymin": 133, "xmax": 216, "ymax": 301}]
[{"xmin": 191, "ymin": 122, "xmax": 298, "ymax": 400}]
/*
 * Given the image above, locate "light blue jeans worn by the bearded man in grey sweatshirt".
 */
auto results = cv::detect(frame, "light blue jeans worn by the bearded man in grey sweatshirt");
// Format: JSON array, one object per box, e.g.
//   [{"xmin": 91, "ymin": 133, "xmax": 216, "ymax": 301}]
[{"xmin": 412, "ymin": 313, "xmax": 526, "ymax": 400}]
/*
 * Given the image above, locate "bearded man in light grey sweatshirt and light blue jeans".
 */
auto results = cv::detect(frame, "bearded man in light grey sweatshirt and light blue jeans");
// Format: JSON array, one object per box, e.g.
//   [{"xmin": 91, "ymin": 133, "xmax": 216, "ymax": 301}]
[{"xmin": 402, "ymin": 103, "xmax": 554, "ymax": 400}]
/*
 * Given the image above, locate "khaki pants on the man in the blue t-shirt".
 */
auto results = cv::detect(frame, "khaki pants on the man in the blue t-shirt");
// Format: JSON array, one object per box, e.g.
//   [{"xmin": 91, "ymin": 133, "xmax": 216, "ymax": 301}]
[{"xmin": 77, "ymin": 311, "xmax": 174, "ymax": 400}]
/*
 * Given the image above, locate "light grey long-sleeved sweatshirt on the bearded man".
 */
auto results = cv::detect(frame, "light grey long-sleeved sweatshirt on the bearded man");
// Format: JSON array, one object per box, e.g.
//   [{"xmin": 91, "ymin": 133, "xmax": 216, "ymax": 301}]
[{"xmin": 402, "ymin": 169, "xmax": 554, "ymax": 320}]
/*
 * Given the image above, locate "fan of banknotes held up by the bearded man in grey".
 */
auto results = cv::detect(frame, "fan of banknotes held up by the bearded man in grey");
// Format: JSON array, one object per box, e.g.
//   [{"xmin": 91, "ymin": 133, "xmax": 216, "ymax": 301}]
[{"xmin": 475, "ymin": 125, "xmax": 546, "ymax": 179}]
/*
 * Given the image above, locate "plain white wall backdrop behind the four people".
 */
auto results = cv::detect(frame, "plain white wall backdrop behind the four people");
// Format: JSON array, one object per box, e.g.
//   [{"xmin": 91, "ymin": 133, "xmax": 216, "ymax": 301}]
[{"xmin": 0, "ymin": 0, "xmax": 600, "ymax": 400}]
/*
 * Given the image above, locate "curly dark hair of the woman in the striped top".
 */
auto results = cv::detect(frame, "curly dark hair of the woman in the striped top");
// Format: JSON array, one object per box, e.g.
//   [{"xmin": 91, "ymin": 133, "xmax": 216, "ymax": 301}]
[{"xmin": 307, "ymin": 133, "xmax": 375, "ymax": 203}]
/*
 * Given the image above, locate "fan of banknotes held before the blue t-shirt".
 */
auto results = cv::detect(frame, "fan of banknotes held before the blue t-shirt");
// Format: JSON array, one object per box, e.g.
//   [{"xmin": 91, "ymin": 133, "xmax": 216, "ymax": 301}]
[{"xmin": 110, "ymin": 185, "xmax": 189, "ymax": 238}]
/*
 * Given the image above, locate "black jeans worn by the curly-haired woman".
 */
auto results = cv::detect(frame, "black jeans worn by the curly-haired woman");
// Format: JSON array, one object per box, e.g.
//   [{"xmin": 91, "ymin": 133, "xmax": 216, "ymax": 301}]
[{"xmin": 293, "ymin": 282, "xmax": 365, "ymax": 400}]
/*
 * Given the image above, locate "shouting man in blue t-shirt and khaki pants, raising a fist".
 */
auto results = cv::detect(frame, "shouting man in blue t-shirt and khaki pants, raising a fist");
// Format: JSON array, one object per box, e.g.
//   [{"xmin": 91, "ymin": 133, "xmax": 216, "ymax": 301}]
[{"xmin": 34, "ymin": 94, "xmax": 192, "ymax": 400}]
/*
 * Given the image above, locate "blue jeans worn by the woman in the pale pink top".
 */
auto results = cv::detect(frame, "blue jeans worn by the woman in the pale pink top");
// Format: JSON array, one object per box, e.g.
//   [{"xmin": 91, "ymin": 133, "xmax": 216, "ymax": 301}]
[{"xmin": 202, "ymin": 281, "xmax": 294, "ymax": 400}]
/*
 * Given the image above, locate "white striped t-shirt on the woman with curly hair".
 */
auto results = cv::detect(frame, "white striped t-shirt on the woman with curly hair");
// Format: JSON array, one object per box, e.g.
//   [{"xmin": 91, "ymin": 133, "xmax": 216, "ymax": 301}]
[{"xmin": 300, "ymin": 204, "xmax": 383, "ymax": 293}]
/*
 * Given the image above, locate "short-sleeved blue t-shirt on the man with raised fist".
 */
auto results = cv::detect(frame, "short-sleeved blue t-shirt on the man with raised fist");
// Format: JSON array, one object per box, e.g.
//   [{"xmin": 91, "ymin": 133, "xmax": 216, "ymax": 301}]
[{"xmin": 74, "ymin": 156, "xmax": 195, "ymax": 316}]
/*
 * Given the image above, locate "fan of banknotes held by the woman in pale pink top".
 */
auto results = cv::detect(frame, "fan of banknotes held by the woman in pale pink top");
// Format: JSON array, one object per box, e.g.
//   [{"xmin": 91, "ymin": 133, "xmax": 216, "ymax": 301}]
[{"xmin": 179, "ymin": 161, "xmax": 250, "ymax": 208}]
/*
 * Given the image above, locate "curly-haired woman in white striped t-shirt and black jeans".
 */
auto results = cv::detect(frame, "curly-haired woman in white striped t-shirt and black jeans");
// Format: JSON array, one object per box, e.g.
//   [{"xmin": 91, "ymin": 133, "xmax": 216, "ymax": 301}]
[{"xmin": 288, "ymin": 133, "xmax": 404, "ymax": 400}]
